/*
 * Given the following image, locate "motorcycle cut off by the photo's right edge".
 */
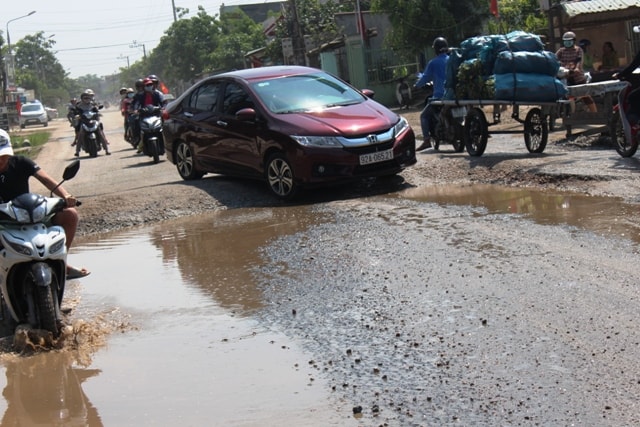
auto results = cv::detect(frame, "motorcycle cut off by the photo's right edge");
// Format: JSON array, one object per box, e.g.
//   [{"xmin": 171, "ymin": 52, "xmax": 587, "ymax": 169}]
[{"xmin": 609, "ymin": 70, "xmax": 640, "ymax": 157}]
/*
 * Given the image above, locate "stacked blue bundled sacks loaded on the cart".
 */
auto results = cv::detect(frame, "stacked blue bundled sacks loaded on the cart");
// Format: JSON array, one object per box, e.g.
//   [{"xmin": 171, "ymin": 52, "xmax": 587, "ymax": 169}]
[{"xmin": 445, "ymin": 31, "xmax": 567, "ymax": 102}]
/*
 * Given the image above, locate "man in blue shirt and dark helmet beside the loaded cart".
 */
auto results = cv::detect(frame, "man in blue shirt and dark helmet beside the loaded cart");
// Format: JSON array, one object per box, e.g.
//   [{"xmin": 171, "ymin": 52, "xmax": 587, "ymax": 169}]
[{"xmin": 415, "ymin": 37, "xmax": 449, "ymax": 151}]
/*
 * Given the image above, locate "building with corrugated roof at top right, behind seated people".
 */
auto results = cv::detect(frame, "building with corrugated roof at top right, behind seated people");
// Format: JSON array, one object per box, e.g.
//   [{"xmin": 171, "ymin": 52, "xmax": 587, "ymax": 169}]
[{"xmin": 540, "ymin": 0, "xmax": 640, "ymax": 69}]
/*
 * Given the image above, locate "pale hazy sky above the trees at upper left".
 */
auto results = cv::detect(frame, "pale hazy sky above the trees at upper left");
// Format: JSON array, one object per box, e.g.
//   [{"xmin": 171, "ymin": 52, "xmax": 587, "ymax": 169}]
[{"xmin": 0, "ymin": 0, "xmax": 274, "ymax": 78}]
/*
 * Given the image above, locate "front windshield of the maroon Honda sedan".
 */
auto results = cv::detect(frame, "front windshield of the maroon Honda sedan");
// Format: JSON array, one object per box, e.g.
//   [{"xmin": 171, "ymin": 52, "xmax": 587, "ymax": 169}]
[{"xmin": 253, "ymin": 73, "xmax": 365, "ymax": 114}]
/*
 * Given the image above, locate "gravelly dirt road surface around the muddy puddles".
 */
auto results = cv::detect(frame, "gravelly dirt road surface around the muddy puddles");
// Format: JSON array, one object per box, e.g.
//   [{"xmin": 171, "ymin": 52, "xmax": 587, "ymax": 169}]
[{"xmin": 22, "ymin": 104, "xmax": 640, "ymax": 426}]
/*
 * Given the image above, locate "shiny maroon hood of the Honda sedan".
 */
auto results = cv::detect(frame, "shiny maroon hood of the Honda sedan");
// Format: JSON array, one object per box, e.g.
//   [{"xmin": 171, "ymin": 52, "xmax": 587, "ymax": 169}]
[{"xmin": 277, "ymin": 100, "xmax": 398, "ymax": 137}]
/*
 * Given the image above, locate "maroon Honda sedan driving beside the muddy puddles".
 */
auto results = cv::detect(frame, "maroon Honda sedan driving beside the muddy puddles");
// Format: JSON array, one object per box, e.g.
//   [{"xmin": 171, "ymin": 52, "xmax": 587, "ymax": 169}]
[{"xmin": 163, "ymin": 66, "xmax": 416, "ymax": 199}]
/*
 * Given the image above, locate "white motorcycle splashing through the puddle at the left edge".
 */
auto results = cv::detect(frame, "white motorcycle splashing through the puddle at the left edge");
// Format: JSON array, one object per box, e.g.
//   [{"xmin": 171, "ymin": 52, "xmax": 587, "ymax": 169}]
[{"xmin": 0, "ymin": 160, "xmax": 80, "ymax": 337}]
